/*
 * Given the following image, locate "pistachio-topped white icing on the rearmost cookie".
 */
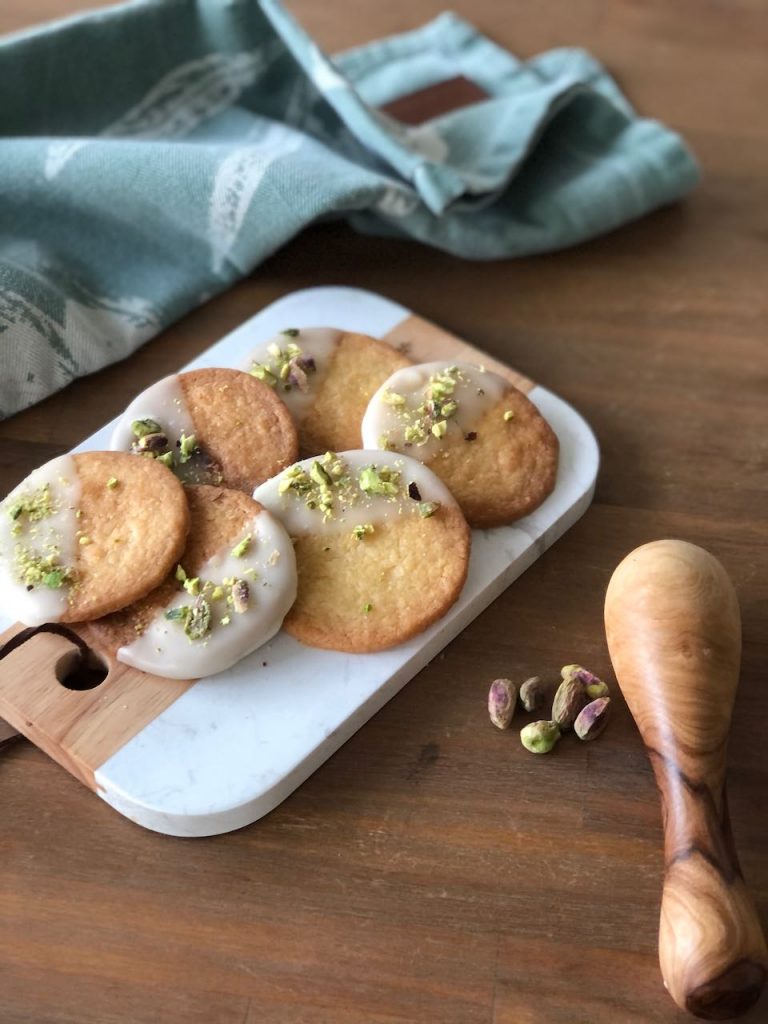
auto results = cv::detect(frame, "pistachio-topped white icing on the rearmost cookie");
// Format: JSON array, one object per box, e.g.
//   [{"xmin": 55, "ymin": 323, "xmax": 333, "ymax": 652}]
[{"xmin": 241, "ymin": 327, "xmax": 343, "ymax": 423}]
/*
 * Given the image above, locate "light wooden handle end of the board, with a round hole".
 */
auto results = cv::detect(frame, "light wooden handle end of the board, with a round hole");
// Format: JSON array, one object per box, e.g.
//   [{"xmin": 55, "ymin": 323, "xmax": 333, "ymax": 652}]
[{"xmin": 0, "ymin": 626, "xmax": 191, "ymax": 790}]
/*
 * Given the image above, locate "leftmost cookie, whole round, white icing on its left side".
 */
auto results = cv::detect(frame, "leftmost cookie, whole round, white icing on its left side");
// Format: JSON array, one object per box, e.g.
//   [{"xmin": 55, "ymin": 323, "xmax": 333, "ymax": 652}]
[{"xmin": 0, "ymin": 452, "xmax": 189, "ymax": 626}]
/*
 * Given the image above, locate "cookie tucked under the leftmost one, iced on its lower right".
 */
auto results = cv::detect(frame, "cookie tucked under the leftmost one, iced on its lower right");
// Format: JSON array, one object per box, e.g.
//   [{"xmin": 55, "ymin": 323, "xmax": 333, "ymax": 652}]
[{"xmin": 90, "ymin": 484, "xmax": 296, "ymax": 679}]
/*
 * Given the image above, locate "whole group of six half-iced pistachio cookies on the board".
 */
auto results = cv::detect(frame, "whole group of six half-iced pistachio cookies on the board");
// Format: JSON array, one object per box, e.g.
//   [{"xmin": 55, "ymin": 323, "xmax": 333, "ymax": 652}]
[{"xmin": 0, "ymin": 328, "xmax": 557, "ymax": 679}]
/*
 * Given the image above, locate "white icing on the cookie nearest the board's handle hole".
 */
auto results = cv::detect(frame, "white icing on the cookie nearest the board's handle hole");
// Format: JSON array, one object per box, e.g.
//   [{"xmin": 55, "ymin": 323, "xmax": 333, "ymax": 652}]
[{"xmin": 117, "ymin": 511, "xmax": 297, "ymax": 679}]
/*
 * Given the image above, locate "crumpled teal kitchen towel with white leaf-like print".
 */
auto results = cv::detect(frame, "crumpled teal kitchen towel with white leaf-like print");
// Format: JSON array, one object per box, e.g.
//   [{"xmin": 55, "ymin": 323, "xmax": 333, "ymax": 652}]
[{"xmin": 0, "ymin": 0, "xmax": 698, "ymax": 417}]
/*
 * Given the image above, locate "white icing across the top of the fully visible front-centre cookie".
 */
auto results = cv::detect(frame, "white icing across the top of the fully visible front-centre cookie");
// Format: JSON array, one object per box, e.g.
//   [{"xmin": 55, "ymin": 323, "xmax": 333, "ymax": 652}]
[{"xmin": 253, "ymin": 450, "xmax": 458, "ymax": 537}]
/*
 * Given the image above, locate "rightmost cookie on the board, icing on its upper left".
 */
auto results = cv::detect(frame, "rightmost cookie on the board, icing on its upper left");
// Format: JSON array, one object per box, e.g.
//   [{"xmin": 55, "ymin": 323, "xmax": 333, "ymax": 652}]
[{"xmin": 362, "ymin": 362, "xmax": 558, "ymax": 527}]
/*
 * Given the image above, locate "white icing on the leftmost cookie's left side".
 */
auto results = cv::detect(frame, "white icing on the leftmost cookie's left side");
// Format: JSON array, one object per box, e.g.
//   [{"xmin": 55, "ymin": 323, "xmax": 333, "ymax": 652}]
[{"xmin": 0, "ymin": 455, "xmax": 80, "ymax": 626}]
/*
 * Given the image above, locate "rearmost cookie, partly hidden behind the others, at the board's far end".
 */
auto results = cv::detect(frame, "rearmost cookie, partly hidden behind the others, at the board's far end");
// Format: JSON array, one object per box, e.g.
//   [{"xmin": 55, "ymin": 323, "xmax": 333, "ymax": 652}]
[{"xmin": 243, "ymin": 328, "xmax": 411, "ymax": 456}]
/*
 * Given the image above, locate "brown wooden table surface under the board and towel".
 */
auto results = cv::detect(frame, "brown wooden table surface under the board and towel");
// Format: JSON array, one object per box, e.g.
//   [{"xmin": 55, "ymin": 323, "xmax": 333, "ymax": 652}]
[{"xmin": 0, "ymin": 0, "xmax": 768, "ymax": 1024}]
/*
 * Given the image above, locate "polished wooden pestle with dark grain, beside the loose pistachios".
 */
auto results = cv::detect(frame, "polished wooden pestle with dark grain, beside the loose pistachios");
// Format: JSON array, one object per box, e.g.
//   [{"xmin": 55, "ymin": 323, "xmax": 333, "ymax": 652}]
[{"xmin": 605, "ymin": 541, "xmax": 768, "ymax": 1020}]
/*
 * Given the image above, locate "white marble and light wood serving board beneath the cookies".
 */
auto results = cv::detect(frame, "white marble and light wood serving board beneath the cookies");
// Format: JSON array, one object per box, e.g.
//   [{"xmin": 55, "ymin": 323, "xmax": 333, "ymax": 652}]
[{"xmin": 0, "ymin": 288, "xmax": 599, "ymax": 836}]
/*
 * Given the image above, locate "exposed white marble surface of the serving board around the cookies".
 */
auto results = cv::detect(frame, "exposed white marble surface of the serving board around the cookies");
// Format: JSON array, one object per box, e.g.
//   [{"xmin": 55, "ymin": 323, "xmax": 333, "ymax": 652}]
[{"xmin": 0, "ymin": 287, "xmax": 599, "ymax": 837}]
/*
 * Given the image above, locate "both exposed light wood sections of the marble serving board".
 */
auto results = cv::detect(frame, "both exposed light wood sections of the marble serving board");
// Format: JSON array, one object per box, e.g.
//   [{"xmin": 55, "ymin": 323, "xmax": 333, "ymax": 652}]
[{"xmin": 0, "ymin": 315, "xmax": 534, "ymax": 790}]
